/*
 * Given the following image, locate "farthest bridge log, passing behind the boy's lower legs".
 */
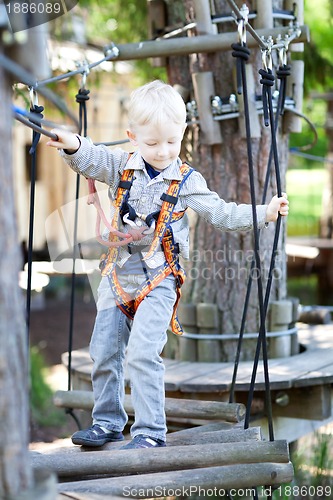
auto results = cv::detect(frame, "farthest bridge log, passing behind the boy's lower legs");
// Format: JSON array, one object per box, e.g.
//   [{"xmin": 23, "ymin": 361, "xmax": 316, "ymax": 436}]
[{"xmin": 53, "ymin": 391, "xmax": 245, "ymax": 422}]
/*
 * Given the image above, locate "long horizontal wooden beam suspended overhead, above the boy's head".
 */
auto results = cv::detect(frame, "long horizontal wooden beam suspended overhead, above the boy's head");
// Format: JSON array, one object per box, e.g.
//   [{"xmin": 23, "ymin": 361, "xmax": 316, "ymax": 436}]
[{"xmin": 106, "ymin": 25, "xmax": 309, "ymax": 62}]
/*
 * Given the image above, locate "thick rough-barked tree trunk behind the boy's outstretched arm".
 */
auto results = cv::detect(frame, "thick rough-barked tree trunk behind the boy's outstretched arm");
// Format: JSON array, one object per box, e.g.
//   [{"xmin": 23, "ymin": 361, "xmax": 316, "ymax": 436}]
[{"xmin": 167, "ymin": 0, "xmax": 288, "ymax": 340}]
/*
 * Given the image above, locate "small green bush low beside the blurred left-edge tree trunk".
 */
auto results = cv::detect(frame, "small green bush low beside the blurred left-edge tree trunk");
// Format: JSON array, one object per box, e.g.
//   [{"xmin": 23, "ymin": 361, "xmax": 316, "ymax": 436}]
[{"xmin": 30, "ymin": 346, "xmax": 65, "ymax": 426}]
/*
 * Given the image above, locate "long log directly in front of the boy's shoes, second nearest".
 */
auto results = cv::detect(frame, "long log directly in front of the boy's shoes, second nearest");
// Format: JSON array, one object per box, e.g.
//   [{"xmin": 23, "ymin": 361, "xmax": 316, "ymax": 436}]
[{"xmin": 30, "ymin": 441, "xmax": 289, "ymax": 479}]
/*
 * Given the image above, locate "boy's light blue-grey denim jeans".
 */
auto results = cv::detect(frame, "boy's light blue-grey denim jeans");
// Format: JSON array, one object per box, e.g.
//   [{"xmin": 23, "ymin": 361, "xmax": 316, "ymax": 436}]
[{"xmin": 90, "ymin": 275, "xmax": 176, "ymax": 440}]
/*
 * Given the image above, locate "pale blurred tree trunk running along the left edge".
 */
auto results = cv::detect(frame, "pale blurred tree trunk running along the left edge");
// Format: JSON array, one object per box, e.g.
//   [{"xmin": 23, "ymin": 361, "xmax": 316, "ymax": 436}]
[{"xmin": 0, "ymin": 47, "xmax": 32, "ymax": 499}]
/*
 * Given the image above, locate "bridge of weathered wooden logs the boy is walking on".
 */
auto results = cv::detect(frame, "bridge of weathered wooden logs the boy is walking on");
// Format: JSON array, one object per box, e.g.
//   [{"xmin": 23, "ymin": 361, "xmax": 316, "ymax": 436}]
[{"xmin": 30, "ymin": 398, "xmax": 293, "ymax": 500}]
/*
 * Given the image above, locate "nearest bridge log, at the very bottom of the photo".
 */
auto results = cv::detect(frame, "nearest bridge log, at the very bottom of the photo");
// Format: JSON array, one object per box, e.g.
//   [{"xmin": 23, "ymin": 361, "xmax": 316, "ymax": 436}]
[{"xmin": 58, "ymin": 462, "xmax": 294, "ymax": 498}]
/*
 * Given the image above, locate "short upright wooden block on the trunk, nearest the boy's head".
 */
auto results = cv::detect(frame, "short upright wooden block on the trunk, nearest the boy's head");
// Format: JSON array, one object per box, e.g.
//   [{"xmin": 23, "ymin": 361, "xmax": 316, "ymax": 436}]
[{"xmin": 192, "ymin": 71, "xmax": 222, "ymax": 145}]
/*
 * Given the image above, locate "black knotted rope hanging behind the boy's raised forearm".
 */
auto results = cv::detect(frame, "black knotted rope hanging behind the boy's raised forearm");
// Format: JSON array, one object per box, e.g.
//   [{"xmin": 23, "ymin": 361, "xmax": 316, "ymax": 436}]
[{"xmin": 66, "ymin": 88, "xmax": 90, "ymax": 429}]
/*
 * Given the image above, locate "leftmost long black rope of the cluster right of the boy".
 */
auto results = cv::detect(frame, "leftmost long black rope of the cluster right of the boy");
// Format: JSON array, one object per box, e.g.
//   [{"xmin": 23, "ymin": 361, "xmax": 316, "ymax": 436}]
[{"xmin": 232, "ymin": 44, "xmax": 274, "ymax": 446}]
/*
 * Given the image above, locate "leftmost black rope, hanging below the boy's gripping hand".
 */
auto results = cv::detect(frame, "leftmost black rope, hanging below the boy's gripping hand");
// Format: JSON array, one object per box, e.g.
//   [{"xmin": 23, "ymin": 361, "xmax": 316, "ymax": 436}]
[{"xmin": 26, "ymin": 105, "xmax": 44, "ymax": 343}]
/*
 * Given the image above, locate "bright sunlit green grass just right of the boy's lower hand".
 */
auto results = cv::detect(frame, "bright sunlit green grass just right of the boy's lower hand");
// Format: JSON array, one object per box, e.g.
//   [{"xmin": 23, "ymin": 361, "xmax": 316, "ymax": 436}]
[{"xmin": 287, "ymin": 168, "xmax": 327, "ymax": 236}]
